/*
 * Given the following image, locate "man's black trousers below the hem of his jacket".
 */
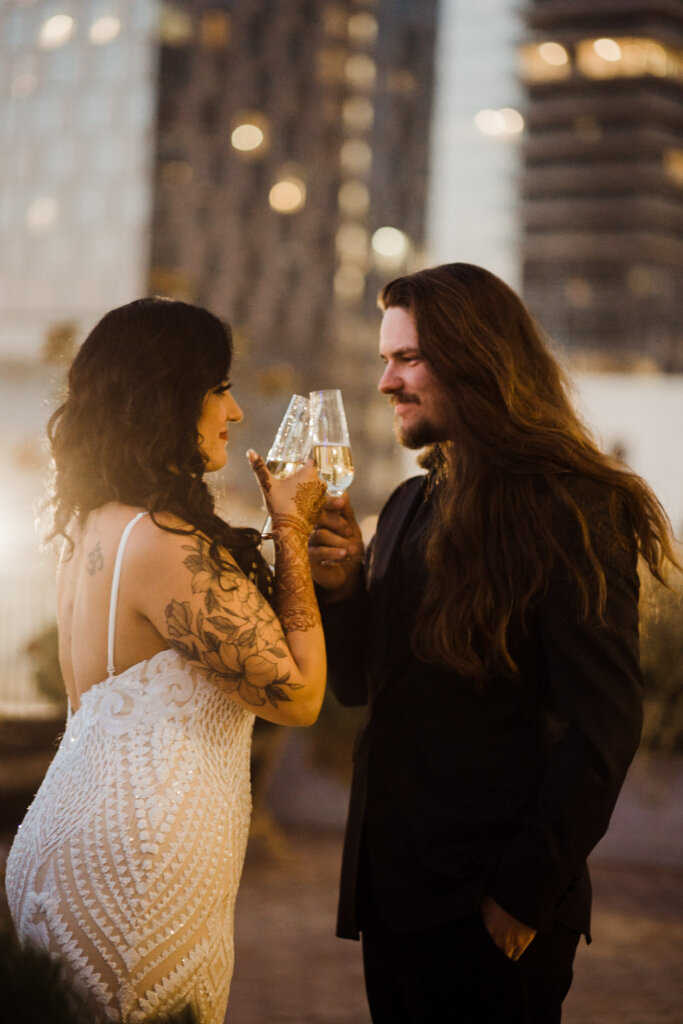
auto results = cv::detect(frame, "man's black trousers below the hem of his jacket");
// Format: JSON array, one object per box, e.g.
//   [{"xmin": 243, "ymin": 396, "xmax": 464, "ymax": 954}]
[{"xmin": 362, "ymin": 901, "xmax": 579, "ymax": 1024}]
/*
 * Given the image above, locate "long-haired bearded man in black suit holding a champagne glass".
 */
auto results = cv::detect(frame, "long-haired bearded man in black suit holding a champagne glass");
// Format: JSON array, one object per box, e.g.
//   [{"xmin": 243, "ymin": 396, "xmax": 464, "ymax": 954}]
[{"xmin": 309, "ymin": 263, "xmax": 674, "ymax": 1024}]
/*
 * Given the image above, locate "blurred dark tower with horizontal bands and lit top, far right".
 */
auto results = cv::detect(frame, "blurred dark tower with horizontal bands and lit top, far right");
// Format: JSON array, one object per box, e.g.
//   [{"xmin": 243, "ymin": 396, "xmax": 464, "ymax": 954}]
[{"xmin": 521, "ymin": 0, "xmax": 683, "ymax": 373}]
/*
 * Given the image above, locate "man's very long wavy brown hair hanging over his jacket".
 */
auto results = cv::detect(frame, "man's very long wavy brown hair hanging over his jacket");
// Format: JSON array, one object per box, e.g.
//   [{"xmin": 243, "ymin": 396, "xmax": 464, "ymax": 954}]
[{"xmin": 379, "ymin": 263, "xmax": 676, "ymax": 679}]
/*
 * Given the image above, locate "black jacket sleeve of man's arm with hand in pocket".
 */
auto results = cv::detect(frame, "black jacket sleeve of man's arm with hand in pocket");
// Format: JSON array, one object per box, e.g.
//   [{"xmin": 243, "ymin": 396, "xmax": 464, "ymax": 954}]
[{"xmin": 489, "ymin": 512, "xmax": 642, "ymax": 930}]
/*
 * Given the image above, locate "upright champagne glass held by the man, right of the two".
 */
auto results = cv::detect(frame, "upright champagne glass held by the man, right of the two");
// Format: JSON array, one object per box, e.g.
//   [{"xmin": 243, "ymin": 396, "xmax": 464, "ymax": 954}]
[{"xmin": 310, "ymin": 389, "xmax": 353, "ymax": 498}]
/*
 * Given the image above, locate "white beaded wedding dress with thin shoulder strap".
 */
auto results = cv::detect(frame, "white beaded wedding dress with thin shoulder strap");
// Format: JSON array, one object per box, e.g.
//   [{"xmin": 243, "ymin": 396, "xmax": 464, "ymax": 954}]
[{"xmin": 6, "ymin": 513, "xmax": 254, "ymax": 1024}]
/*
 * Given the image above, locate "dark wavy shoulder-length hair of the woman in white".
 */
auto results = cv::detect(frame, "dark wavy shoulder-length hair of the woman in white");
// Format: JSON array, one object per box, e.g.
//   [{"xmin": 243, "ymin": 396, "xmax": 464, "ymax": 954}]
[{"xmin": 47, "ymin": 298, "xmax": 268, "ymax": 590}]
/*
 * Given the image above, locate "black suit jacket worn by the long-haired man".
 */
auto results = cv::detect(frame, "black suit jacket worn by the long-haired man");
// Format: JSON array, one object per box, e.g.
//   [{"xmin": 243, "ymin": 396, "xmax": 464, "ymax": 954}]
[{"xmin": 322, "ymin": 477, "xmax": 642, "ymax": 938}]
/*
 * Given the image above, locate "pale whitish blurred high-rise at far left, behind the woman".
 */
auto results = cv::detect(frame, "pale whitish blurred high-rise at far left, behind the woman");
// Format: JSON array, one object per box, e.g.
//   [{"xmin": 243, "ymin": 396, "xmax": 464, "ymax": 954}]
[{"xmin": 0, "ymin": 0, "xmax": 155, "ymax": 359}]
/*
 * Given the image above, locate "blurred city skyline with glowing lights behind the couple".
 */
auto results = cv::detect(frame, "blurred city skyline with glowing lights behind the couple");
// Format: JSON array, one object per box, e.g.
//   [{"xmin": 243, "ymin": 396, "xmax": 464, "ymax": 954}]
[{"xmin": 0, "ymin": 0, "xmax": 683, "ymax": 698}]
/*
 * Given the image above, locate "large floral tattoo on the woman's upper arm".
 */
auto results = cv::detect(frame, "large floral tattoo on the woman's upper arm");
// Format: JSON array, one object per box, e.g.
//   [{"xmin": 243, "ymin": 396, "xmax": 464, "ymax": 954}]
[{"xmin": 165, "ymin": 537, "xmax": 301, "ymax": 708}]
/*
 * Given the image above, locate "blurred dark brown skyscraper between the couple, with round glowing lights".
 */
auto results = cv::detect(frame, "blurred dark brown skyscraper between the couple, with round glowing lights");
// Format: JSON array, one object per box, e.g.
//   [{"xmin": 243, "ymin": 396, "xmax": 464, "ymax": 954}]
[{"xmin": 151, "ymin": 0, "xmax": 435, "ymax": 501}]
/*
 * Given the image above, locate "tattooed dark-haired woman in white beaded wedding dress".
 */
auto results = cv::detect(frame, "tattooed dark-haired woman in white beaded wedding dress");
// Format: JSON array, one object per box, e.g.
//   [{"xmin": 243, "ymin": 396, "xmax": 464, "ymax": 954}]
[{"xmin": 6, "ymin": 299, "xmax": 326, "ymax": 1024}]
